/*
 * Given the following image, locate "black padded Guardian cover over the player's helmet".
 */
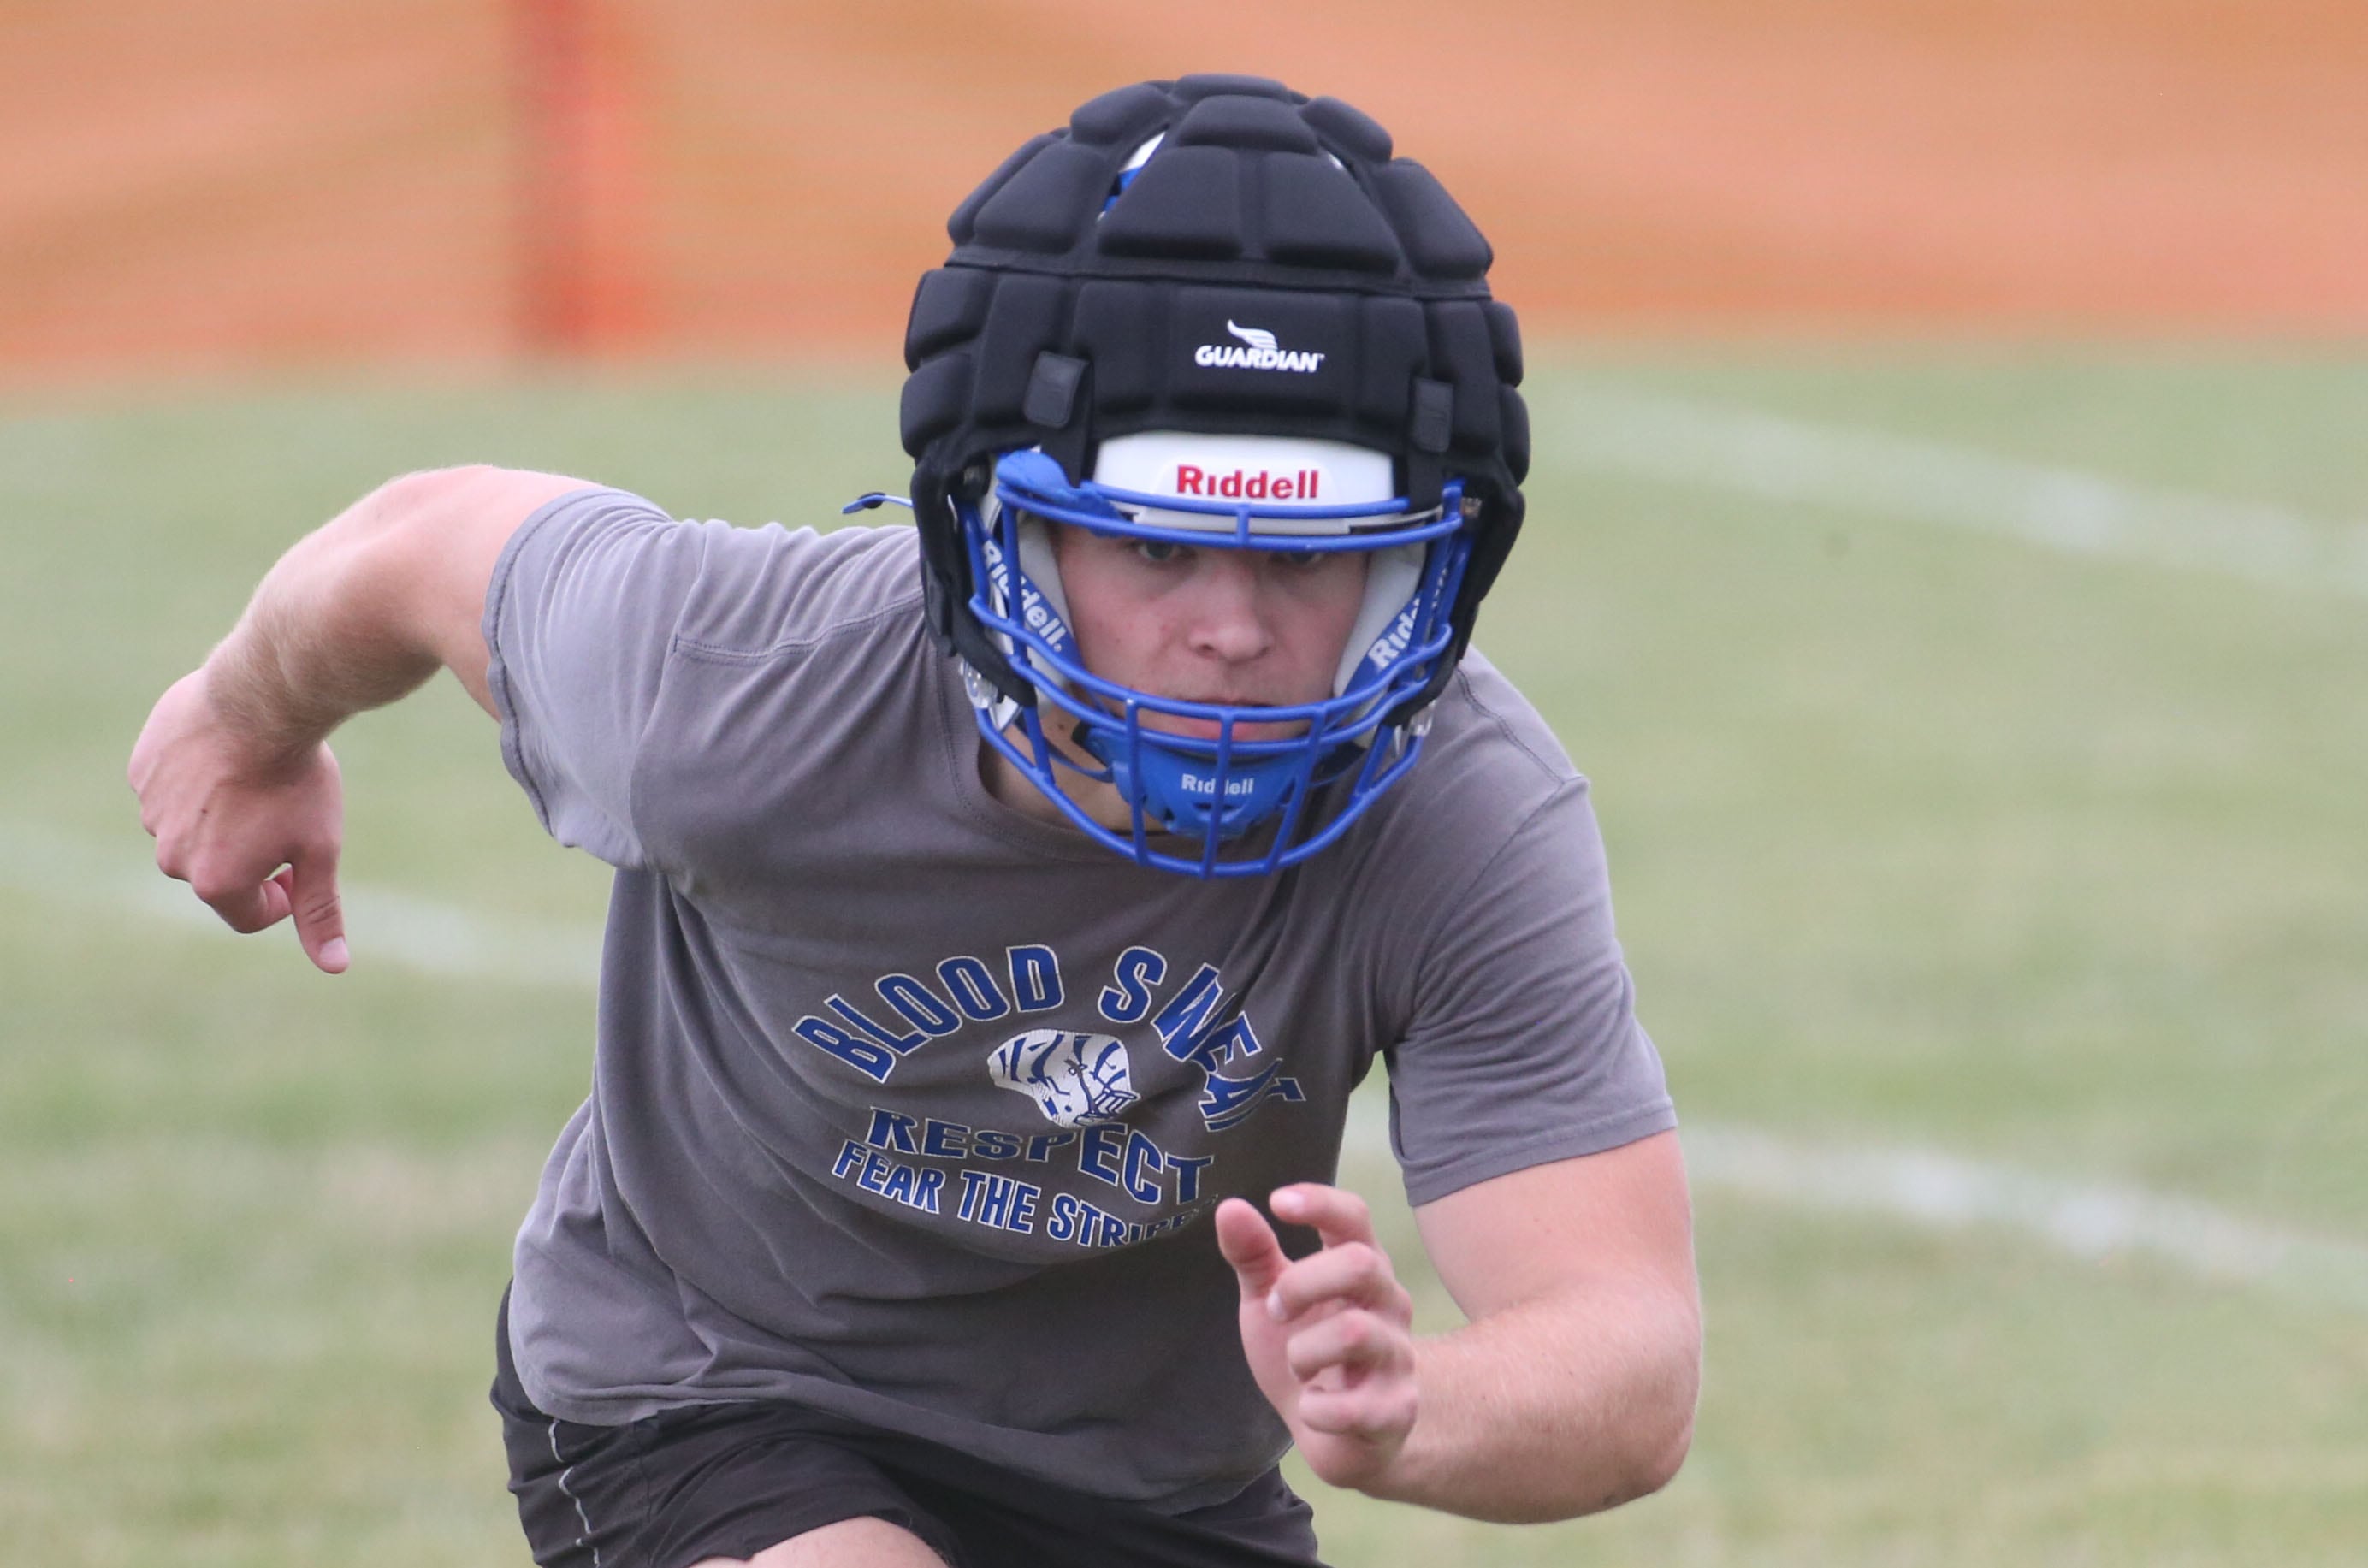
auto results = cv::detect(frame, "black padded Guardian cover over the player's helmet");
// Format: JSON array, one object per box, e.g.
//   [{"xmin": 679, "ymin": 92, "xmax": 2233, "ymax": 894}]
[{"xmin": 900, "ymin": 76, "xmax": 1530, "ymax": 706}]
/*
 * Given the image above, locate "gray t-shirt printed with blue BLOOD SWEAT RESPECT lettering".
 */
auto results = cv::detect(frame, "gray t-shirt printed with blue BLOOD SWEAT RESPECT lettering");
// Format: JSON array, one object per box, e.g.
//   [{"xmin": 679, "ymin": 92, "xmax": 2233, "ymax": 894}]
[{"xmin": 485, "ymin": 490, "xmax": 1674, "ymax": 1509}]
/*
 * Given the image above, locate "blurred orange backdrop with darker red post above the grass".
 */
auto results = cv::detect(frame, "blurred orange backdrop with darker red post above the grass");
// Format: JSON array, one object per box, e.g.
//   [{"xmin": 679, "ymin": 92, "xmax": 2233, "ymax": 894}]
[{"xmin": 0, "ymin": 0, "xmax": 2368, "ymax": 384}]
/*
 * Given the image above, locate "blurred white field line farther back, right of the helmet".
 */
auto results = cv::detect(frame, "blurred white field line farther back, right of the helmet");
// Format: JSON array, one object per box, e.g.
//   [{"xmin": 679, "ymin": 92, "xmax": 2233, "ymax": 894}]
[{"xmin": 1535, "ymin": 386, "xmax": 2368, "ymax": 597}]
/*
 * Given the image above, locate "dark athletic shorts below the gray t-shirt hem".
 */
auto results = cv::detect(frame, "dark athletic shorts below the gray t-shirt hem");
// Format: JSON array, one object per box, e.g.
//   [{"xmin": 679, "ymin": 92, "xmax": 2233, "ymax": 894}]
[{"xmin": 493, "ymin": 1293, "xmax": 1322, "ymax": 1568}]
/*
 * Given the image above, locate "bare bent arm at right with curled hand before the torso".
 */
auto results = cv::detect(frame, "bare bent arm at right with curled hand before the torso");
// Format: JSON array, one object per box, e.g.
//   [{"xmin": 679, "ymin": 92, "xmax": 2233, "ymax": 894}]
[{"xmin": 1217, "ymin": 1133, "xmax": 1702, "ymax": 1523}]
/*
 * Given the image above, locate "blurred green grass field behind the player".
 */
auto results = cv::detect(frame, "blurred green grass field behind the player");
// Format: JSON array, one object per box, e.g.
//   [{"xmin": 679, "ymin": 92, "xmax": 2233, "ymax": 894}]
[{"xmin": 0, "ymin": 348, "xmax": 2368, "ymax": 1568}]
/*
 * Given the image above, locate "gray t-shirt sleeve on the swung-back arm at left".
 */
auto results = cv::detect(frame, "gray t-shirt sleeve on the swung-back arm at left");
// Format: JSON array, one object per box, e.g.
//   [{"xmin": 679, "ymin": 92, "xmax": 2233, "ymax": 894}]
[{"xmin": 485, "ymin": 490, "xmax": 710, "ymax": 869}]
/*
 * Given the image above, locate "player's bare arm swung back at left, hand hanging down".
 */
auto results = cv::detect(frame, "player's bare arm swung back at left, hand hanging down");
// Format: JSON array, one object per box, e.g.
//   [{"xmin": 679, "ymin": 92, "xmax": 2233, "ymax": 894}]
[{"xmin": 127, "ymin": 469, "xmax": 583, "ymax": 973}]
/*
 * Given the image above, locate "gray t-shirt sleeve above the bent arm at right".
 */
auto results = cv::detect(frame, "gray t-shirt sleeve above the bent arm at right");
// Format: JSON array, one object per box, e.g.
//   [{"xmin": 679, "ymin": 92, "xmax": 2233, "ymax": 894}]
[{"xmin": 1388, "ymin": 777, "xmax": 1677, "ymax": 1205}]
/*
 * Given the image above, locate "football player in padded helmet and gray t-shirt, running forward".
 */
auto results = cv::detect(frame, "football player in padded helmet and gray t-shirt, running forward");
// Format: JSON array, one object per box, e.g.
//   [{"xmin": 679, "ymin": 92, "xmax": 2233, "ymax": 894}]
[{"xmin": 130, "ymin": 76, "xmax": 1700, "ymax": 1568}]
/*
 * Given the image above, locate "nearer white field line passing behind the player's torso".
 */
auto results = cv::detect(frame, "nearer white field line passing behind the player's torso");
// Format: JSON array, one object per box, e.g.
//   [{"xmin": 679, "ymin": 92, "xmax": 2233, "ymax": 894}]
[{"xmin": 18, "ymin": 820, "xmax": 2368, "ymax": 1312}]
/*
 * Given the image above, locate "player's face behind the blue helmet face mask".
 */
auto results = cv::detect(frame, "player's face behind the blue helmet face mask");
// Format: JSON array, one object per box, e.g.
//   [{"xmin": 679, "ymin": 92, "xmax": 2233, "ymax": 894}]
[{"xmin": 1054, "ymin": 528, "xmax": 1369, "ymax": 742}]
